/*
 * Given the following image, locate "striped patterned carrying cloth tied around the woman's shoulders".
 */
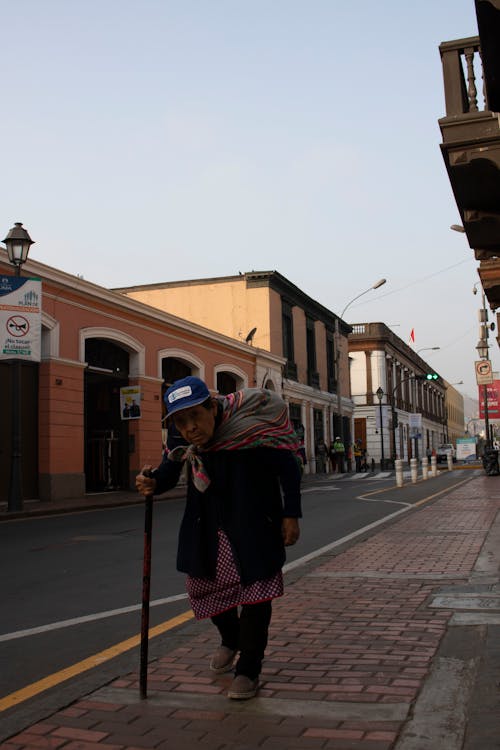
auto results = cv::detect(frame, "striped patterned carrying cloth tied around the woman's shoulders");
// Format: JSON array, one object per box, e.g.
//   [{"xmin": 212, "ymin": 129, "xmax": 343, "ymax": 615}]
[{"xmin": 167, "ymin": 388, "xmax": 301, "ymax": 492}]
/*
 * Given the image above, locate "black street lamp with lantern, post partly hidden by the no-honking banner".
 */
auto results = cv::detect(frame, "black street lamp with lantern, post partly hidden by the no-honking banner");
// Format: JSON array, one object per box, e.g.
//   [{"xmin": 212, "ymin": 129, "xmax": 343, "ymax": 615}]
[{"xmin": 3, "ymin": 222, "xmax": 33, "ymax": 512}]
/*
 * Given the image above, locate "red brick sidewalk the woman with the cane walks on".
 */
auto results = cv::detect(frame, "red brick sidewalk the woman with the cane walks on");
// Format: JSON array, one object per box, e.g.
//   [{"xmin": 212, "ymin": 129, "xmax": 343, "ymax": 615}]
[{"xmin": 0, "ymin": 477, "xmax": 500, "ymax": 750}]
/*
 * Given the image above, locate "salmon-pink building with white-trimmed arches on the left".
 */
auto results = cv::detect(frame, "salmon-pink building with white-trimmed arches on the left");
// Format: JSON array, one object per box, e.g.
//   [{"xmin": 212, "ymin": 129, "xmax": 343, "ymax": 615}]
[{"xmin": 0, "ymin": 249, "xmax": 284, "ymax": 502}]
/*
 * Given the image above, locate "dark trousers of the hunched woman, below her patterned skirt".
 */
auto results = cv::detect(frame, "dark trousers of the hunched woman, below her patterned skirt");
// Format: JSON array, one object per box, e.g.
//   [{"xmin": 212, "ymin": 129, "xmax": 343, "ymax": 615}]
[{"xmin": 211, "ymin": 601, "xmax": 272, "ymax": 680}]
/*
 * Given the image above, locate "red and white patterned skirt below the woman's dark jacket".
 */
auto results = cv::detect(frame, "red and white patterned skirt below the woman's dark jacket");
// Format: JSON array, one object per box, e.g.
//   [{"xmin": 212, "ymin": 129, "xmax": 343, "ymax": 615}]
[{"xmin": 186, "ymin": 529, "xmax": 283, "ymax": 620}]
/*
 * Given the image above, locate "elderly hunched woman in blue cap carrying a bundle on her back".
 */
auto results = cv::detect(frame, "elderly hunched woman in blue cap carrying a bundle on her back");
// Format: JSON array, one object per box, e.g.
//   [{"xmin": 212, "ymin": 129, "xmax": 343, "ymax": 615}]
[{"xmin": 136, "ymin": 376, "xmax": 302, "ymax": 699}]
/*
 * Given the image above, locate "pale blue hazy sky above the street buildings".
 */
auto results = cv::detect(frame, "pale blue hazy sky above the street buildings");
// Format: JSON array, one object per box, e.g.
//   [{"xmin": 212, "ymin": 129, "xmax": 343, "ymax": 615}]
[{"xmin": 0, "ymin": 0, "xmax": 492, "ymax": 406}]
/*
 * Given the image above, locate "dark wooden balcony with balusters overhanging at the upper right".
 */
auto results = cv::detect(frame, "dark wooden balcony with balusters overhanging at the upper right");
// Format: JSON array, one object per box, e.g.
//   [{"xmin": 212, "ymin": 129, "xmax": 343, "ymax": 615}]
[{"xmin": 439, "ymin": 5, "xmax": 500, "ymax": 309}]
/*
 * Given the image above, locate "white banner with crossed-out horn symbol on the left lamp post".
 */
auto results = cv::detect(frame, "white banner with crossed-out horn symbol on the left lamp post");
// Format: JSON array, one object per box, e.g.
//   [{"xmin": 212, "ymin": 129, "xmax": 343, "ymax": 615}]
[{"xmin": 0, "ymin": 276, "xmax": 42, "ymax": 362}]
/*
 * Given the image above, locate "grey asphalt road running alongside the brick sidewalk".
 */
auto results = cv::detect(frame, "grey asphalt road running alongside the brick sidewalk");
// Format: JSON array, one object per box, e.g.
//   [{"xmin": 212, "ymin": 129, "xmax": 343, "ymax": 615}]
[{"xmin": 0, "ymin": 470, "xmax": 475, "ymax": 738}]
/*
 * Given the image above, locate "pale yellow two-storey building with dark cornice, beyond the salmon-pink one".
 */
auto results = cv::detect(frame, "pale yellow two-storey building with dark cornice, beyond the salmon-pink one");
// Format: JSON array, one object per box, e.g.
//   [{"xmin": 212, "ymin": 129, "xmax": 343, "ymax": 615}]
[{"xmin": 115, "ymin": 271, "xmax": 353, "ymax": 472}]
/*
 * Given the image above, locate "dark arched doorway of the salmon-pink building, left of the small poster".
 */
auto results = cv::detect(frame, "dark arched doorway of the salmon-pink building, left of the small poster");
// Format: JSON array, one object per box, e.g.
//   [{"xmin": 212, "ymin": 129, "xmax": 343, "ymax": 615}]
[{"xmin": 84, "ymin": 339, "xmax": 129, "ymax": 492}]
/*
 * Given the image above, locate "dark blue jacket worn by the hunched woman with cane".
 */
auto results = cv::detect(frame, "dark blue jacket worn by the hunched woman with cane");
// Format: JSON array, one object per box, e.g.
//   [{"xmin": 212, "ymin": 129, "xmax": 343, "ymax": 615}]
[{"xmin": 153, "ymin": 448, "xmax": 302, "ymax": 585}]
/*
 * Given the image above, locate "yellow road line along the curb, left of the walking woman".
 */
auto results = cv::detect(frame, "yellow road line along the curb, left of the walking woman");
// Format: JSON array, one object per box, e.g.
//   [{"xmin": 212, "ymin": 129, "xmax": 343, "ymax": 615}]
[{"xmin": 0, "ymin": 611, "xmax": 194, "ymax": 713}]
